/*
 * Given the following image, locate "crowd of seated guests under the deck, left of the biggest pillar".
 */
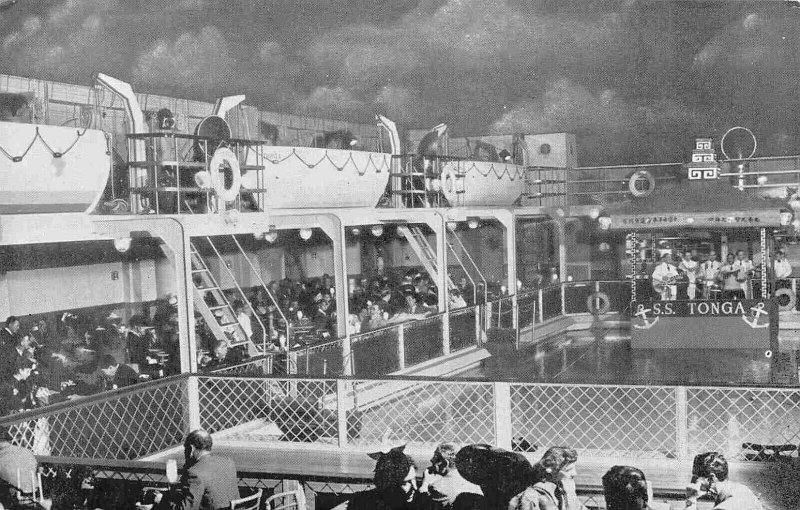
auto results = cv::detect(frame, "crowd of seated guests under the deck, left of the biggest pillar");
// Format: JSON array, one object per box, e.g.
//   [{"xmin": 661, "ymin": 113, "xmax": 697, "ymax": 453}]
[{"xmin": 0, "ymin": 297, "xmax": 180, "ymax": 416}]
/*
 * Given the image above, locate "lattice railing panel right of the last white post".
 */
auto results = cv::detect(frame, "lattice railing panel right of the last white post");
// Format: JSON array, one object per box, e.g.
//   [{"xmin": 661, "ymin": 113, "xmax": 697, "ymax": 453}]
[{"xmin": 687, "ymin": 388, "xmax": 800, "ymax": 460}]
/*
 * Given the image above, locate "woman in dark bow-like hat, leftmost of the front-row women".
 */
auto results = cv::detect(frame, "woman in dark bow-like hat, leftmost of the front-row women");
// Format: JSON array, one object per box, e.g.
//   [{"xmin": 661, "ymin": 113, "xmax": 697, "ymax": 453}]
[{"xmin": 347, "ymin": 446, "xmax": 437, "ymax": 510}]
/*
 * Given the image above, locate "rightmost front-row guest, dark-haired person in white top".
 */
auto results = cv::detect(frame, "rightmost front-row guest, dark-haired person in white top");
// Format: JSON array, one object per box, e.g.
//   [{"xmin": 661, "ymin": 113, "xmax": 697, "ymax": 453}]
[{"xmin": 686, "ymin": 452, "xmax": 764, "ymax": 510}]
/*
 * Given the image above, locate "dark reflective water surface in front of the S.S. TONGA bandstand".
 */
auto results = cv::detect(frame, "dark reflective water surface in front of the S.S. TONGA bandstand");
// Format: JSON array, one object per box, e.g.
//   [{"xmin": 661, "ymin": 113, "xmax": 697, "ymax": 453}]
[{"xmin": 478, "ymin": 328, "xmax": 797, "ymax": 385}]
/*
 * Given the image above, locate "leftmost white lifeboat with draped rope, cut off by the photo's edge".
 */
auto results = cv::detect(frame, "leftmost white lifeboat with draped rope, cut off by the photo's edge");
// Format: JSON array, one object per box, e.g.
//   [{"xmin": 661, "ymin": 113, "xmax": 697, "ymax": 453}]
[{"xmin": 0, "ymin": 122, "xmax": 111, "ymax": 214}]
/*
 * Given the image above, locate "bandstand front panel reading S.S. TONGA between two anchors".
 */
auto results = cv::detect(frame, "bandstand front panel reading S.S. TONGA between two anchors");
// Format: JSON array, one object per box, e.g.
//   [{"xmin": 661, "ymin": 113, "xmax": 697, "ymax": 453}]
[{"xmin": 631, "ymin": 299, "xmax": 778, "ymax": 353}]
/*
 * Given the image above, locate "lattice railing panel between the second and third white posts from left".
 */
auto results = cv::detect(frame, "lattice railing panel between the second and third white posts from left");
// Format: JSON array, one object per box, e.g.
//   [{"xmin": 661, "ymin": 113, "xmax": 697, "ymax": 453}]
[{"xmin": 345, "ymin": 381, "xmax": 495, "ymax": 447}]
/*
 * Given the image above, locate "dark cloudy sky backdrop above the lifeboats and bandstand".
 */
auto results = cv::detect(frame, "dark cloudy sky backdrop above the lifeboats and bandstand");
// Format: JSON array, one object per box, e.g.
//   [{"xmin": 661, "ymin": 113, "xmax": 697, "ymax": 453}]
[{"xmin": 0, "ymin": 0, "xmax": 800, "ymax": 164}]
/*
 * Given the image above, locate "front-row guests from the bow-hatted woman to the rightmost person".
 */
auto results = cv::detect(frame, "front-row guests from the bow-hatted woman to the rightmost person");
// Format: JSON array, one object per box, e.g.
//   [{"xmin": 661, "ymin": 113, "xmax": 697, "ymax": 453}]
[{"xmin": 334, "ymin": 443, "xmax": 763, "ymax": 510}]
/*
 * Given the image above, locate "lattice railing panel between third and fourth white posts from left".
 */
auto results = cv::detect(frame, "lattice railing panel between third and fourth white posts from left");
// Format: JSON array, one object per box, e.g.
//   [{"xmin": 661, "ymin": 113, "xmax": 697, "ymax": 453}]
[{"xmin": 511, "ymin": 384, "xmax": 677, "ymax": 458}]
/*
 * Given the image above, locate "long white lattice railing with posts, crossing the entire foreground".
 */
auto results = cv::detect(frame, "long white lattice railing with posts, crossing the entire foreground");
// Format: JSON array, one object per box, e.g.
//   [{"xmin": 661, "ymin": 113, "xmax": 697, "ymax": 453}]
[{"xmin": 0, "ymin": 368, "xmax": 800, "ymax": 465}]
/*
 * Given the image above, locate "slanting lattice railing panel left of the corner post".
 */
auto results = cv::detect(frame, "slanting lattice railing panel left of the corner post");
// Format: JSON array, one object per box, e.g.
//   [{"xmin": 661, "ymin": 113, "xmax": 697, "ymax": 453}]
[{"xmin": 3, "ymin": 378, "xmax": 187, "ymax": 459}]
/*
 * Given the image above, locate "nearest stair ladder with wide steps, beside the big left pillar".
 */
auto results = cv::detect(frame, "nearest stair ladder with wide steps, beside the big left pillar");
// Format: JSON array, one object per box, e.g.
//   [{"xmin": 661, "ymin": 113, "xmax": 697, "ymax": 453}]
[{"xmin": 189, "ymin": 243, "xmax": 258, "ymax": 355}]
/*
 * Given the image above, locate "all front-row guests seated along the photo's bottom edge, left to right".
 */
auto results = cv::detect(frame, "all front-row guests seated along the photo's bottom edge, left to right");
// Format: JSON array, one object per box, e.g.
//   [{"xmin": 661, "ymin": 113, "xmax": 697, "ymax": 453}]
[{"xmin": 0, "ymin": 430, "xmax": 764, "ymax": 510}]
